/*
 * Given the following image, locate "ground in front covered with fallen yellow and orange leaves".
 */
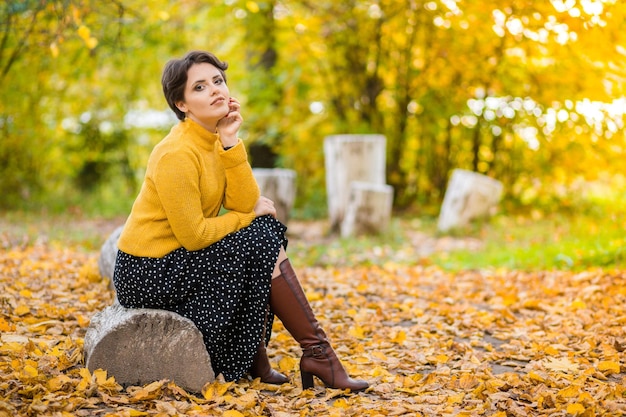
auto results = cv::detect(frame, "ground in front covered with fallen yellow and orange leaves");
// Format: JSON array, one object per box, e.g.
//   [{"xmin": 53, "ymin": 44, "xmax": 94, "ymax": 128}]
[{"xmin": 0, "ymin": 229, "xmax": 626, "ymax": 417}]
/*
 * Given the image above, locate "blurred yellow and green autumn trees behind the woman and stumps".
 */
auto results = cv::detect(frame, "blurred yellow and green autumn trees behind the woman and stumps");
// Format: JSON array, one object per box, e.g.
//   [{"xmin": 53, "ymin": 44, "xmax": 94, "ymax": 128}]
[{"xmin": 0, "ymin": 0, "xmax": 626, "ymax": 231}]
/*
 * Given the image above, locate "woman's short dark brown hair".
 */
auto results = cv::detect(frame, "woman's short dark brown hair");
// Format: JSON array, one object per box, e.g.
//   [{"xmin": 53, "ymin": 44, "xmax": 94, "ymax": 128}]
[{"xmin": 161, "ymin": 51, "xmax": 228, "ymax": 120}]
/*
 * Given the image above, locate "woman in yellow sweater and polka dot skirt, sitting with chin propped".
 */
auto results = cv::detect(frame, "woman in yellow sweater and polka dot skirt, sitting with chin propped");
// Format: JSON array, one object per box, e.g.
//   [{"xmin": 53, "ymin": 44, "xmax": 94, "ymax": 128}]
[{"xmin": 113, "ymin": 51, "xmax": 368, "ymax": 391}]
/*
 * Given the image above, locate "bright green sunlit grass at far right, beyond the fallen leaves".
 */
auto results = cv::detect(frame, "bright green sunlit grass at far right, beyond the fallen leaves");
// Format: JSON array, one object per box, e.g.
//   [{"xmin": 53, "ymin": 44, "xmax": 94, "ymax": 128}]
[{"xmin": 432, "ymin": 213, "xmax": 626, "ymax": 271}]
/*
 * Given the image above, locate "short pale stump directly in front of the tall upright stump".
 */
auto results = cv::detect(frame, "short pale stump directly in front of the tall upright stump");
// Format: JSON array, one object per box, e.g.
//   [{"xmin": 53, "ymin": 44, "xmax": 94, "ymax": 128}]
[{"xmin": 341, "ymin": 181, "xmax": 393, "ymax": 237}]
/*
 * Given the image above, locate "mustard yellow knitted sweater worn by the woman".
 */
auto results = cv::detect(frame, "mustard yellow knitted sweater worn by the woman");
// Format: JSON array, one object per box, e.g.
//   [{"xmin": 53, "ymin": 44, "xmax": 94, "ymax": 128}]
[{"xmin": 118, "ymin": 119, "xmax": 260, "ymax": 258}]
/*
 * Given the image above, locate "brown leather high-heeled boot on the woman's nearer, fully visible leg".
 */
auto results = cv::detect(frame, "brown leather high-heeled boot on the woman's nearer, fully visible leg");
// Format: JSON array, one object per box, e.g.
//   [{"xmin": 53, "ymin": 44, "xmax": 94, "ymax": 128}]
[{"xmin": 270, "ymin": 259, "xmax": 369, "ymax": 392}]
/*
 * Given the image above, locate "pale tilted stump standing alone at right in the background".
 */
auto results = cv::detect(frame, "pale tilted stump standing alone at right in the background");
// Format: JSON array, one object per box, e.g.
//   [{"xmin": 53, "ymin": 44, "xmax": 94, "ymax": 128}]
[{"xmin": 437, "ymin": 169, "xmax": 502, "ymax": 232}]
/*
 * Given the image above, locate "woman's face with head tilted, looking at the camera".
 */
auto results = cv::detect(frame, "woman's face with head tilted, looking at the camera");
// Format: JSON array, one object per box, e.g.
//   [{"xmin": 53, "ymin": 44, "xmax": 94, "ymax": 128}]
[{"xmin": 176, "ymin": 62, "xmax": 230, "ymax": 132}]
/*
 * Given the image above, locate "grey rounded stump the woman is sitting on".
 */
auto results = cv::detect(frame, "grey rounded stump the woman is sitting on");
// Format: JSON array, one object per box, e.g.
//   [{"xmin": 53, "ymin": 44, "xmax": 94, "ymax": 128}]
[{"xmin": 84, "ymin": 303, "xmax": 215, "ymax": 392}]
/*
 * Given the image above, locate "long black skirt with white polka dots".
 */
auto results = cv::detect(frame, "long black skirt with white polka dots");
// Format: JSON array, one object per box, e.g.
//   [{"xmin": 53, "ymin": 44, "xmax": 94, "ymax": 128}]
[{"xmin": 113, "ymin": 216, "xmax": 287, "ymax": 381}]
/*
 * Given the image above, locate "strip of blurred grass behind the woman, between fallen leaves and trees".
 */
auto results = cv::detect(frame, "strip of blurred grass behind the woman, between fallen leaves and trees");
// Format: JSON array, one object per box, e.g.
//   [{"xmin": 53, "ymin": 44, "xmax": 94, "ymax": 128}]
[{"xmin": 0, "ymin": 205, "xmax": 626, "ymax": 271}]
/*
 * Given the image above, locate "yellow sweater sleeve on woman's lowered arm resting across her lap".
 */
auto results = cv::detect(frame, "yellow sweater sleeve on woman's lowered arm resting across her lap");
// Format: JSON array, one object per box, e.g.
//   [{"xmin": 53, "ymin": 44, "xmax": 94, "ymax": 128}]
[{"xmin": 154, "ymin": 152, "xmax": 252, "ymax": 251}]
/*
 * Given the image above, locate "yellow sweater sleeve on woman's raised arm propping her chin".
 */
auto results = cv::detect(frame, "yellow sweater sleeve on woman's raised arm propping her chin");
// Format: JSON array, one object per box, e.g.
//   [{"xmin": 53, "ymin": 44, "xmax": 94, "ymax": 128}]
[{"xmin": 218, "ymin": 139, "xmax": 260, "ymax": 213}]
